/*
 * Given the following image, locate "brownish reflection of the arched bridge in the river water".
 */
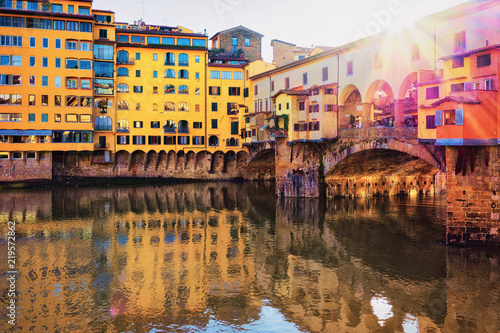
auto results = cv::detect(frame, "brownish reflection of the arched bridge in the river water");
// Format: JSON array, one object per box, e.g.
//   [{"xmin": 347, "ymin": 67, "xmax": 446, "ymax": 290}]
[{"xmin": 255, "ymin": 200, "xmax": 500, "ymax": 332}]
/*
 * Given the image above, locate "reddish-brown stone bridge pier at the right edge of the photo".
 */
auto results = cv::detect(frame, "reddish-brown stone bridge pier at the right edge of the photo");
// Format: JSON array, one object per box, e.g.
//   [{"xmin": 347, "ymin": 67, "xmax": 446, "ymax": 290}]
[{"xmin": 446, "ymin": 147, "xmax": 500, "ymax": 245}]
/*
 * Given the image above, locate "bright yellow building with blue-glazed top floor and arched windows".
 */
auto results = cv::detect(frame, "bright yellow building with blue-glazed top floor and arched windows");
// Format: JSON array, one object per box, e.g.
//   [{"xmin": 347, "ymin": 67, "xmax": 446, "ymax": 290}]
[{"xmin": 116, "ymin": 24, "xmax": 207, "ymax": 152}]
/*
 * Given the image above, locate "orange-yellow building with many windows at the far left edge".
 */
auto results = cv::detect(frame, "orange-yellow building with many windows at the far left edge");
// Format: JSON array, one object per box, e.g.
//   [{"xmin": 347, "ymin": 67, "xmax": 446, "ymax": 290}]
[{"xmin": 0, "ymin": 1, "xmax": 93, "ymax": 164}]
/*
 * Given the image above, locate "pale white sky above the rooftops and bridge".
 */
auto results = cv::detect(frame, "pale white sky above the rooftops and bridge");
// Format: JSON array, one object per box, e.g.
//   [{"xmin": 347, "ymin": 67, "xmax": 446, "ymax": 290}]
[{"xmin": 92, "ymin": 0, "xmax": 467, "ymax": 62}]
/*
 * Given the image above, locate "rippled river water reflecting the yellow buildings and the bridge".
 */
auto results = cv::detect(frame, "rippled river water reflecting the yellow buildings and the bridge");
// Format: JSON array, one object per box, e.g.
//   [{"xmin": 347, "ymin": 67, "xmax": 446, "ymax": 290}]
[{"xmin": 0, "ymin": 183, "xmax": 500, "ymax": 333}]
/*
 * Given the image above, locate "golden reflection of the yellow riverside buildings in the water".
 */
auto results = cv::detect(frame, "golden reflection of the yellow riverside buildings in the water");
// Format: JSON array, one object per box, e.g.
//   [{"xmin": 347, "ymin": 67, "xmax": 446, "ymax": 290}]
[{"xmin": 0, "ymin": 184, "xmax": 274, "ymax": 331}]
